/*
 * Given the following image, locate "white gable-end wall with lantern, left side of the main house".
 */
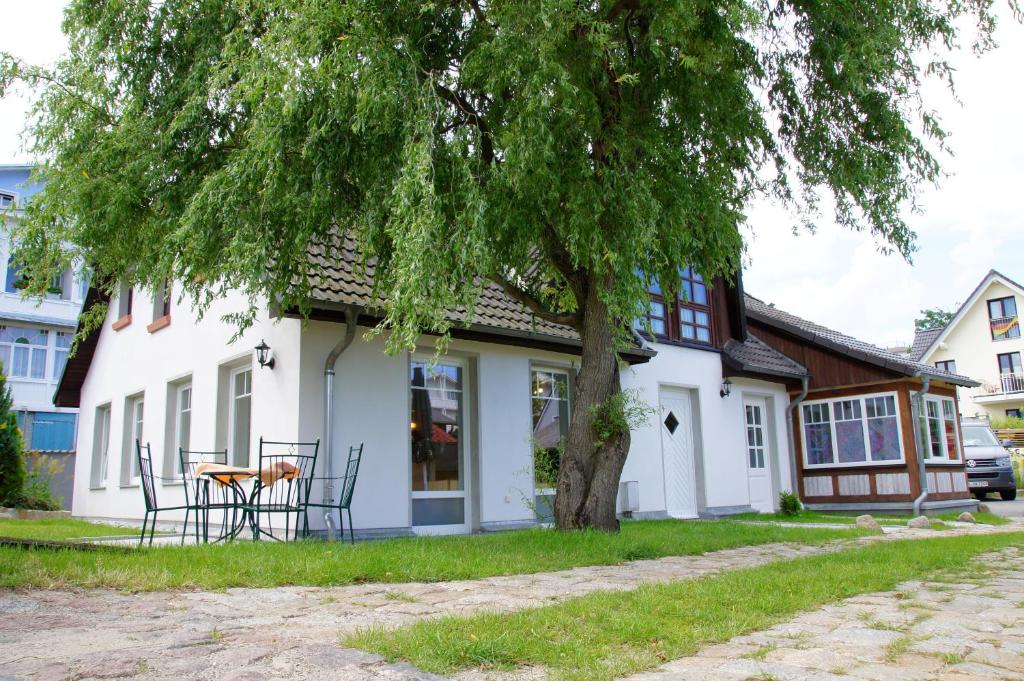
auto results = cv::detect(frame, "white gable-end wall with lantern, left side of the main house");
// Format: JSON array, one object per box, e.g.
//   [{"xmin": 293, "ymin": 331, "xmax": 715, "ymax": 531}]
[{"xmin": 73, "ymin": 292, "xmax": 296, "ymax": 520}]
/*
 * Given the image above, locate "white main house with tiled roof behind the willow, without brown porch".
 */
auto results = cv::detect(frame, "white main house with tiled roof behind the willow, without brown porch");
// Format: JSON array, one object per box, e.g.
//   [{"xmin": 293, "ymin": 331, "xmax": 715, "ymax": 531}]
[{"xmin": 56, "ymin": 242, "xmax": 972, "ymax": 537}]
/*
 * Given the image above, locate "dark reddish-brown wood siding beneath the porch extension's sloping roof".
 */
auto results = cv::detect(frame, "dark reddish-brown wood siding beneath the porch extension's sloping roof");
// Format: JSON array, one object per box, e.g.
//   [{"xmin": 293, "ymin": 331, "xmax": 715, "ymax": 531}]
[{"xmin": 748, "ymin": 318, "xmax": 902, "ymax": 390}]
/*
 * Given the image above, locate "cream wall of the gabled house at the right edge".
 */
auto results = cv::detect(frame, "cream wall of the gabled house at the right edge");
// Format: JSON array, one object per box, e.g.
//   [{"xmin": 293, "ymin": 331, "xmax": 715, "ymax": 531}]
[{"xmin": 923, "ymin": 281, "xmax": 1024, "ymax": 417}]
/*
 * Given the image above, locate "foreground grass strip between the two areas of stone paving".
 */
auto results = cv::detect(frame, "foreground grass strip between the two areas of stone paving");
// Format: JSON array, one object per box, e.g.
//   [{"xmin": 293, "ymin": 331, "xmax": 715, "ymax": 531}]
[{"xmin": 342, "ymin": 534, "xmax": 1024, "ymax": 679}]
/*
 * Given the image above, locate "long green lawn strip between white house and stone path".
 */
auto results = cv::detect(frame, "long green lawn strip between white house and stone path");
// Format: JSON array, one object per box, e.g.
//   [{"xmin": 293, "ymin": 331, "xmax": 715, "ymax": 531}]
[{"xmin": 0, "ymin": 520, "xmax": 864, "ymax": 591}]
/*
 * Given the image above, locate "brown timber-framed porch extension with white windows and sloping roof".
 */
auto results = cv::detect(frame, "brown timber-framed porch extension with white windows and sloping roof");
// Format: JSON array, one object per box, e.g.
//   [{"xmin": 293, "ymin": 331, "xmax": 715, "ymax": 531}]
[{"xmin": 746, "ymin": 296, "xmax": 977, "ymax": 511}]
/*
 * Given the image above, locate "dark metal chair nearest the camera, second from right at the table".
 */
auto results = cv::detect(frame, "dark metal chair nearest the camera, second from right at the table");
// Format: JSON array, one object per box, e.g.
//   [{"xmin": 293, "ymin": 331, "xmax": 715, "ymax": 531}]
[{"xmin": 244, "ymin": 437, "xmax": 319, "ymax": 541}]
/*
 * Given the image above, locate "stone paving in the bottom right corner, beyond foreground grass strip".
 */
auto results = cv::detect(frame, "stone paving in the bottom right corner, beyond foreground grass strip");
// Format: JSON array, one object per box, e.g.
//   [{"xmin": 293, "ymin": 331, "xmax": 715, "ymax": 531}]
[{"xmin": 630, "ymin": 549, "xmax": 1024, "ymax": 681}]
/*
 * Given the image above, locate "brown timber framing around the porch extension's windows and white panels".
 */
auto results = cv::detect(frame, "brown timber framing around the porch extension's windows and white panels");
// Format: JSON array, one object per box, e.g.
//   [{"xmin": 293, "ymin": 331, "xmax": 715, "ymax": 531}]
[{"xmin": 790, "ymin": 382, "xmax": 970, "ymax": 504}]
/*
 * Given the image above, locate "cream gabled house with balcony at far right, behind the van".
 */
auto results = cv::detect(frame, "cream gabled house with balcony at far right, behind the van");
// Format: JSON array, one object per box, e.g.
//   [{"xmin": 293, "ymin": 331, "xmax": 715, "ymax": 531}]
[{"xmin": 911, "ymin": 269, "xmax": 1024, "ymax": 418}]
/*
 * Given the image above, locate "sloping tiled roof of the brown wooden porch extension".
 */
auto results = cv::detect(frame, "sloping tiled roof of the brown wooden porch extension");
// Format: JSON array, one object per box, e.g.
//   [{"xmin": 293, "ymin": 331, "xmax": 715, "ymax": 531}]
[{"xmin": 745, "ymin": 295, "xmax": 980, "ymax": 386}]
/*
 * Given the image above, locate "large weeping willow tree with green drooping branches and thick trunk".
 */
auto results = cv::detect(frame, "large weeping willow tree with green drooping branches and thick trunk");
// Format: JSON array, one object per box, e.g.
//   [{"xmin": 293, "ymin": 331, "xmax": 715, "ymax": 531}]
[{"xmin": 0, "ymin": 0, "xmax": 995, "ymax": 529}]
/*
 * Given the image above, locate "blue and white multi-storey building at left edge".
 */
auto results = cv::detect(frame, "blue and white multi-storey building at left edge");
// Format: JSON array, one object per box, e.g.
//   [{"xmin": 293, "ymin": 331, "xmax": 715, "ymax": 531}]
[{"xmin": 0, "ymin": 165, "xmax": 88, "ymax": 508}]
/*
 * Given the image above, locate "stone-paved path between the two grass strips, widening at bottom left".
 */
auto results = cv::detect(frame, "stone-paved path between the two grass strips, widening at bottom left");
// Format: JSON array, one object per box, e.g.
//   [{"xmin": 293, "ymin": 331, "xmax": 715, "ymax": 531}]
[{"xmin": 0, "ymin": 524, "xmax": 1024, "ymax": 681}]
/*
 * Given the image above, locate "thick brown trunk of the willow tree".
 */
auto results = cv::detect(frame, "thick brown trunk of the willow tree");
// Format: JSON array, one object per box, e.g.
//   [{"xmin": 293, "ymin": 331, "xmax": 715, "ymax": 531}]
[{"xmin": 555, "ymin": 284, "xmax": 630, "ymax": 531}]
